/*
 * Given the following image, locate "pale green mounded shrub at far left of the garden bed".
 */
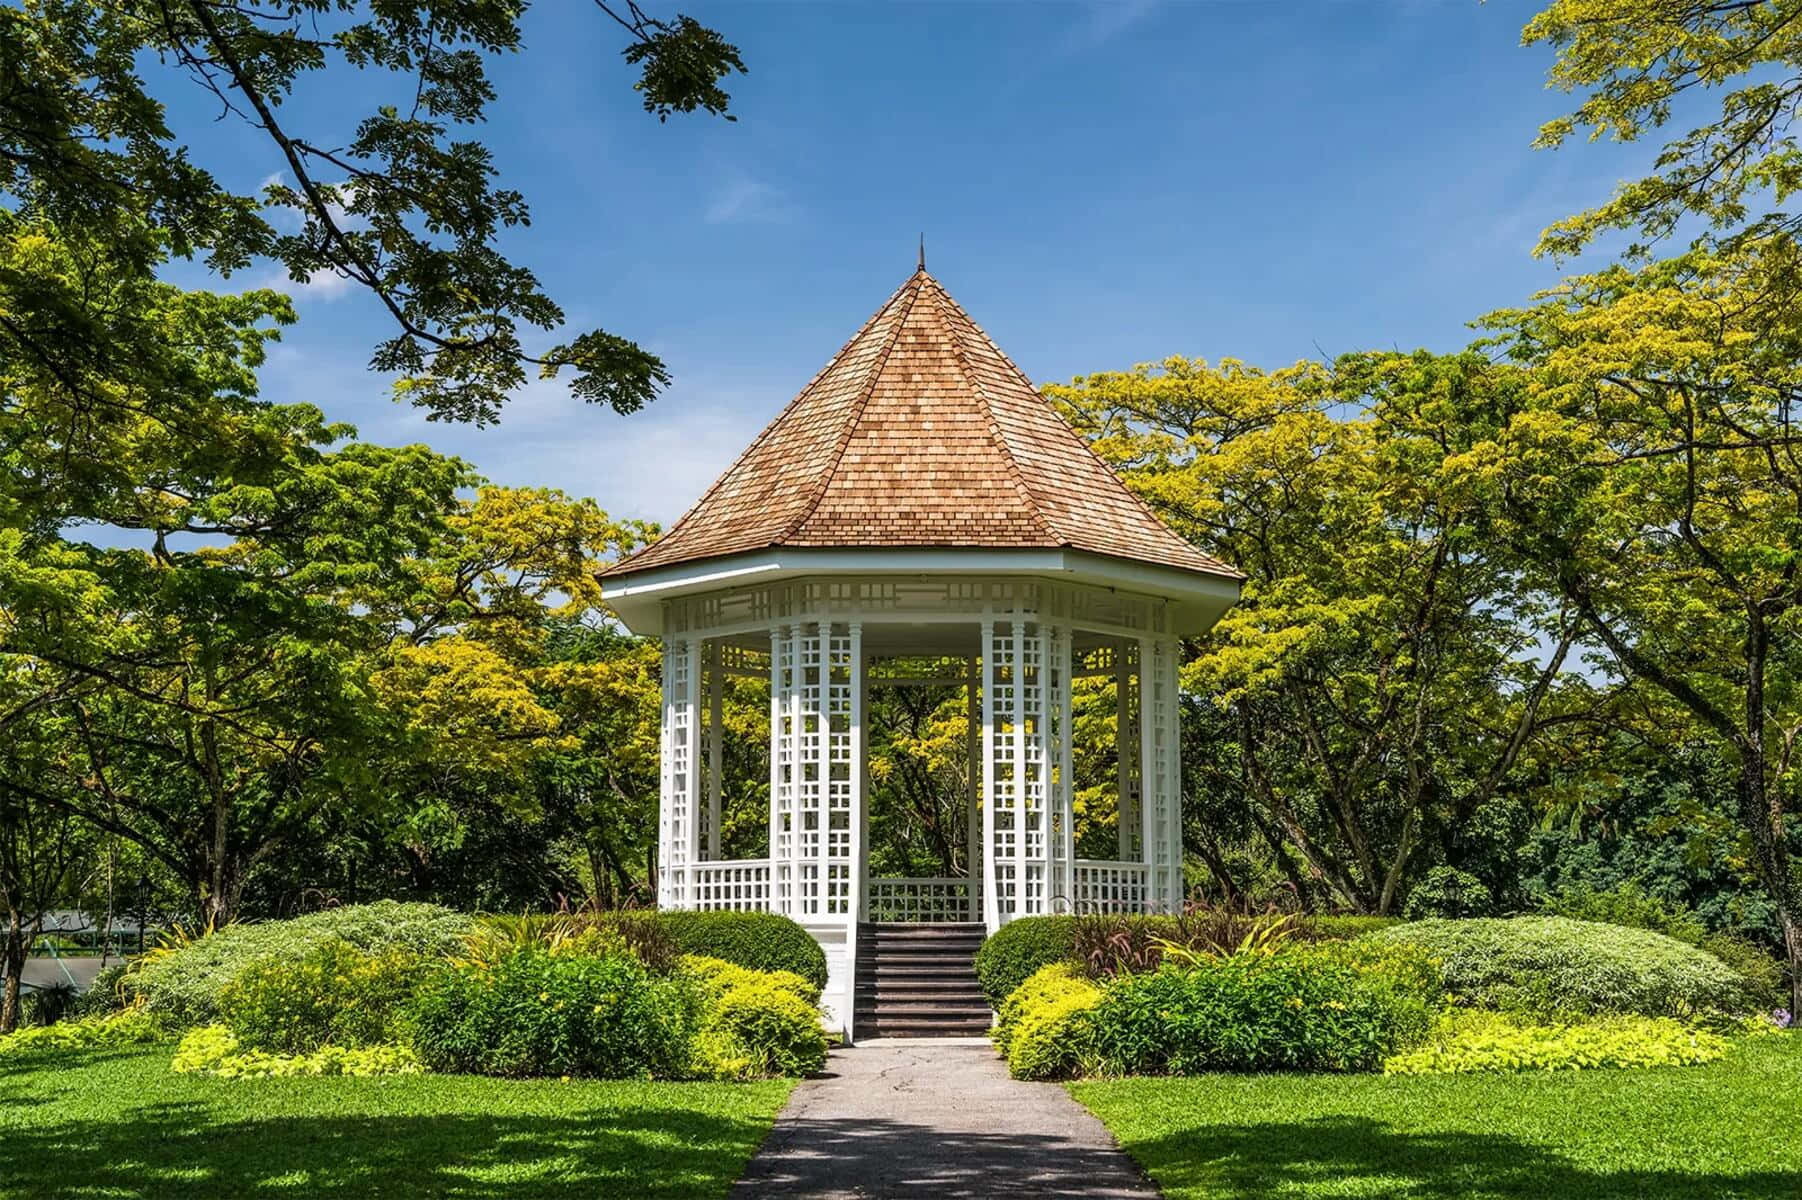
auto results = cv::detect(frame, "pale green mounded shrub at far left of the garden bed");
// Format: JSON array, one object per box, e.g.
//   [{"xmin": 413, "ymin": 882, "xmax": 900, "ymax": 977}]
[{"xmin": 126, "ymin": 901, "xmax": 474, "ymax": 1027}]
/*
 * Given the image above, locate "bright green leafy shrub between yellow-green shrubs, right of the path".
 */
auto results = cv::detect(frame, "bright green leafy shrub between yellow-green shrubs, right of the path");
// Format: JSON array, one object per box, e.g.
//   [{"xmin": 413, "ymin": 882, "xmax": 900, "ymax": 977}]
[{"xmin": 1088, "ymin": 942, "xmax": 1438, "ymax": 1074}]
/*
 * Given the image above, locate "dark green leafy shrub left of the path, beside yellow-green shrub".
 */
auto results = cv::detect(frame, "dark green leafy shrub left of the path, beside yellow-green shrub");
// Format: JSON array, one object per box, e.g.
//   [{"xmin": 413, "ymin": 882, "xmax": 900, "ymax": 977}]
[{"xmin": 409, "ymin": 948, "xmax": 703, "ymax": 1079}]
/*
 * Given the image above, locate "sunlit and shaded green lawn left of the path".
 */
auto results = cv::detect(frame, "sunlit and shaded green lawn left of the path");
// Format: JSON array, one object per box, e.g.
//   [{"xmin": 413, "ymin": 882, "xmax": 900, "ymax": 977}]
[{"xmin": 0, "ymin": 1047, "xmax": 793, "ymax": 1200}]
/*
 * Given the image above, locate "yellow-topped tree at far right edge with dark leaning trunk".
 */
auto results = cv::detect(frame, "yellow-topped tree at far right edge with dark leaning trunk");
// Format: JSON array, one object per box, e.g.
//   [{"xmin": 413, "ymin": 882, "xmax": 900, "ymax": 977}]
[{"xmin": 1463, "ymin": 247, "xmax": 1802, "ymax": 1002}]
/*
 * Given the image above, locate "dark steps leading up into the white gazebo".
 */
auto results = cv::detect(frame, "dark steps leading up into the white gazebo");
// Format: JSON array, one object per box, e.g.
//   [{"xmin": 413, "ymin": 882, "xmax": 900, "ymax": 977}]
[{"xmin": 852, "ymin": 923, "xmax": 993, "ymax": 1040}]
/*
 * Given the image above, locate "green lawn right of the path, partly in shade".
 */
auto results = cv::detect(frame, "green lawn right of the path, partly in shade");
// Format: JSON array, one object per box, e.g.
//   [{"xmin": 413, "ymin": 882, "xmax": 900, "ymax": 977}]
[{"xmin": 1070, "ymin": 1036, "xmax": 1802, "ymax": 1200}]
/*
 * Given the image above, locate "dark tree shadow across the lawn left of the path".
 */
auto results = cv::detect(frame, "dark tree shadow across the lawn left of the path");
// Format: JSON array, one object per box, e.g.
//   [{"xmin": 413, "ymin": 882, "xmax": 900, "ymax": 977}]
[{"xmin": 0, "ymin": 1103, "xmax": 764, "ymax": 1200}]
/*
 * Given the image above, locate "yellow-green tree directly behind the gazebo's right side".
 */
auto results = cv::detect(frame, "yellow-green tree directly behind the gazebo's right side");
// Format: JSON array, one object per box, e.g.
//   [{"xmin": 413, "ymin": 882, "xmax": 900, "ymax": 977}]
[{"xmin": 1047, "ymin": 355, "xmax": 1573, "ymax": 914}]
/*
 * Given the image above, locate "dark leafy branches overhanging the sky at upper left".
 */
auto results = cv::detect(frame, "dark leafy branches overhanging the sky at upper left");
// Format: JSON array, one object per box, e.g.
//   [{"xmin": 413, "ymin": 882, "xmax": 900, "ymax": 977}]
[{"xmin": 0, "ymin": 0, "xmax": 744, "ymax": 423}]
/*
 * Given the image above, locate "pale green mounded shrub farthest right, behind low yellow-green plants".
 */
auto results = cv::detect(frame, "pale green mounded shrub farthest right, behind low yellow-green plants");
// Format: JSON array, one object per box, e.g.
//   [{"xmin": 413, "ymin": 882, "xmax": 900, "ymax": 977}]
[{"xmin": 1364, "ymin": 917, "xmax": 1753, "ymax": 1018}]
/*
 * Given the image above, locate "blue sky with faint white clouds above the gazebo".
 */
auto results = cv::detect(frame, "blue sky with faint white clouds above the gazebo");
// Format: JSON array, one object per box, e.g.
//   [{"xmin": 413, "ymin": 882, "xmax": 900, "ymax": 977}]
[{"xmin": 175, "ymin": 0, "xmax": 1642, "ymax": 523}]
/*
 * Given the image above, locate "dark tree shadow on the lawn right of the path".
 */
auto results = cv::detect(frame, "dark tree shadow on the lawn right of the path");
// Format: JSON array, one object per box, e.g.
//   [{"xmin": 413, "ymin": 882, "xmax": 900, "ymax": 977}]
[{"xmin": 1132, "ymin": 1114, "xmax": 1802, "ymax": 1200}]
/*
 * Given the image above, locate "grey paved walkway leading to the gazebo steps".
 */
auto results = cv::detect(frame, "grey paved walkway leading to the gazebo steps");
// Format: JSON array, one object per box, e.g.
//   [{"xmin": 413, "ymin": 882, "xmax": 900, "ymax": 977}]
[{"xmin": 733, "ymin": 1038, "xmax": 1157, "ymax": 1200}]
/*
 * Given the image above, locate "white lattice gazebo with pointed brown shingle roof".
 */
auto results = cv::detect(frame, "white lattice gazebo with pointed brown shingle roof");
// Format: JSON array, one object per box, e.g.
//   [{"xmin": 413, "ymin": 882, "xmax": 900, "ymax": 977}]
[{"xmin": 602, "ymin": 263, "xmax": 1240, "ymax": 1034}]
